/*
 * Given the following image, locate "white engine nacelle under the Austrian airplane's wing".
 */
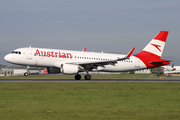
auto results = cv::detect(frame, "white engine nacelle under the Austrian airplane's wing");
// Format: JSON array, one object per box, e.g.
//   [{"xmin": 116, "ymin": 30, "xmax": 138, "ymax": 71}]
[{"xmin": 61, "ymin": 64, "xmax": 79, "ymax": 74}]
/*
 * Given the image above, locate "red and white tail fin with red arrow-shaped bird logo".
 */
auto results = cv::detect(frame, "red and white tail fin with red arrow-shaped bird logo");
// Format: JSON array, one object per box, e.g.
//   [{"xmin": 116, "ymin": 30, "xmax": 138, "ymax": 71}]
[{"xmin": 135, "ymin": 31, "xmax": 169, "ymax": 59}]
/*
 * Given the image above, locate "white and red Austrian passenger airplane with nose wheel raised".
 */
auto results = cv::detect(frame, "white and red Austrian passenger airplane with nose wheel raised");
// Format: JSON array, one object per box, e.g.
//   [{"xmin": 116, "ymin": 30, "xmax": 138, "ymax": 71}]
[{"xmin": 4, "ymin": 31, "xmax": 170, "ymax": 80}]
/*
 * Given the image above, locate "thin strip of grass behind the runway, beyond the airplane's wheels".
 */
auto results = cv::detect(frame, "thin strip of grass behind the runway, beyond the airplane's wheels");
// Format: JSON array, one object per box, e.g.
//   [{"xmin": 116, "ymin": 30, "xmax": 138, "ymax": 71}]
[{"xmin": 0, "ymin": 74, "xmax": 170, "ymax": 80}]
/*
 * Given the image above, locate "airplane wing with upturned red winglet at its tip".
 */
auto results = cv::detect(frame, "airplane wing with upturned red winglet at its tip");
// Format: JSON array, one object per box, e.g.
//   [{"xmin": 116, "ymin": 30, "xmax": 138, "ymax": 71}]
[{"xmin": 67, "ymin": 48, "xmax": 135, "ymax": 69}]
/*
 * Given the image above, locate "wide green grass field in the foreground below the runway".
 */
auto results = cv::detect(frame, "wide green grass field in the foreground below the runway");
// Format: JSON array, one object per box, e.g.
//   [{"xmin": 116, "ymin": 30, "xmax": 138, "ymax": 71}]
[{"xmin": 0, "ymin": 83, "xmax": 180, "ymax": 120}]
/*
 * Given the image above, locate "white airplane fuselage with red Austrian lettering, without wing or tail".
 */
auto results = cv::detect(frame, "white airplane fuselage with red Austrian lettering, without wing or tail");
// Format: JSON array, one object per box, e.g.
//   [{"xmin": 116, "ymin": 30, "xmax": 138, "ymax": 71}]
[{"xmin": 4, "ymin": 47, "xmax": 146, "ymax": 72}]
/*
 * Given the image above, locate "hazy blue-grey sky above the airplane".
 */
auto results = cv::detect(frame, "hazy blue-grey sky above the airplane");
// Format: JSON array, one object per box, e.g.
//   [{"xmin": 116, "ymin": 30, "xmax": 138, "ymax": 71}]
[{"xmin": 0, "ymin": 0, "xmax": 180, "ymax": 65}]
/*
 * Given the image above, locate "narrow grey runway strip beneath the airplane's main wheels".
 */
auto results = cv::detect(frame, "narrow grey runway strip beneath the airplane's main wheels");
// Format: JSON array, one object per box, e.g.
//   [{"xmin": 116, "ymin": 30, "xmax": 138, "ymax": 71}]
[{"xmin": 0, "ymin": 79, "xmax": 180, "ymax": 83}]
